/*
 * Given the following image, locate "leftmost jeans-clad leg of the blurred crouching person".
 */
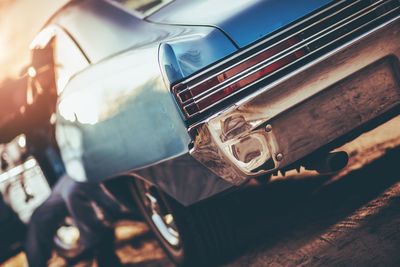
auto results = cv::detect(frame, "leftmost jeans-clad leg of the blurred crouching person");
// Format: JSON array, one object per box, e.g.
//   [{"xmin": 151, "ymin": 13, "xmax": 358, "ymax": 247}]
[{"xmin": 25, "ymin": 181, "xmax": 67, "ymax": 267}]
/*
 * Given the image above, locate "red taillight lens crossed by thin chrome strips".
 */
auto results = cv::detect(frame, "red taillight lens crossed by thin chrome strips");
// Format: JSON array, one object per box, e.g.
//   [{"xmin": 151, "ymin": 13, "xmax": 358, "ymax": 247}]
[{"xmin": 174, "ymin": 37, "xmax": 307, "ymax": 117}]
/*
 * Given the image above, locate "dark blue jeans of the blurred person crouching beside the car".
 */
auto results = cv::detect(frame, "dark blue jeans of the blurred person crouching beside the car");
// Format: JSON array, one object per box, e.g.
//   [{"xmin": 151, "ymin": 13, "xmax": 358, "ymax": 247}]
[{"xmin": 25, "ymin": 175, "xmax": 121, "ymax": 267}]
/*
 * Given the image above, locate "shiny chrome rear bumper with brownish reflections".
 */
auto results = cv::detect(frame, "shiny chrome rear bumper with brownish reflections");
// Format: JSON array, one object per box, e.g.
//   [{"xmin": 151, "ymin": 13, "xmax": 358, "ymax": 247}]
[{"xmin": 189, "ymin": 17, "xmax": 400, "ymax": 185}]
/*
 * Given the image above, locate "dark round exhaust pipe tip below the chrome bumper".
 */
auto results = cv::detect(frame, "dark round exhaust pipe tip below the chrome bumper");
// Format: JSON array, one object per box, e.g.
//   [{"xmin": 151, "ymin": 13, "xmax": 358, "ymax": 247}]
[{"xmin": 304, "ymin": 151, "xmax": 349, "ymax": 174}]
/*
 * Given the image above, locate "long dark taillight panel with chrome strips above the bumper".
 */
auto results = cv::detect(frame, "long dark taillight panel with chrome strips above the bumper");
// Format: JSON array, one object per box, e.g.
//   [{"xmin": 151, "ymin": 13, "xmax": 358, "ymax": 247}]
[{"xmin": 172, "ymin": 0, "xmax": 400, "ymax": 124}]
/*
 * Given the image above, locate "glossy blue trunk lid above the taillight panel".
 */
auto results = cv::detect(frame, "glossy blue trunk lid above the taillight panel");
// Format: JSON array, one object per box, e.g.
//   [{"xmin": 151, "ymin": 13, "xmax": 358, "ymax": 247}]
[{"xmin": 147, "ymin": 0, "xmax": 333, "ymax": 47}]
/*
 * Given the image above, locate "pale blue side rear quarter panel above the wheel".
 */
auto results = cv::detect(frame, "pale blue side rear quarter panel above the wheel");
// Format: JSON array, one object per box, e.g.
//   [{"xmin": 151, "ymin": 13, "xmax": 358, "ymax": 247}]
[{"xmin": 56, "ymin": 36, "xmax": 236, "ymax": 204}]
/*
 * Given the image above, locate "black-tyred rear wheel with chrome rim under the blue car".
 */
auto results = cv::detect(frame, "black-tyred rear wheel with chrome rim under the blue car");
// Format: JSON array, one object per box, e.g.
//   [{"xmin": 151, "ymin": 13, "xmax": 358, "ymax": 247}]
[{"xmin": 132, "ymin": 179, "xmax": 236, "ymax": 266}]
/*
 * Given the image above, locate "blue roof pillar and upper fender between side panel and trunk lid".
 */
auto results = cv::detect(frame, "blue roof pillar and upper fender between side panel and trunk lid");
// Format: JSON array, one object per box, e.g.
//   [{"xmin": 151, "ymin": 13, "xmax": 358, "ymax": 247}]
[{"xmin": 51, "ymin": 0, "xmax": 237, "ymax": 69}]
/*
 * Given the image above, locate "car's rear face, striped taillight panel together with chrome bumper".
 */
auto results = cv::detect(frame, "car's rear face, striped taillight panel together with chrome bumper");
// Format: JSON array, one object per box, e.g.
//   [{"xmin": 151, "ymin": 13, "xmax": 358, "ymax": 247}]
[{"xmin": 172, "ymin": 0, "xmax": 400, "ymax": 185}]
